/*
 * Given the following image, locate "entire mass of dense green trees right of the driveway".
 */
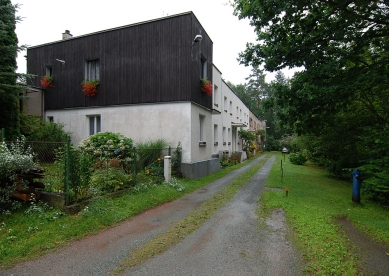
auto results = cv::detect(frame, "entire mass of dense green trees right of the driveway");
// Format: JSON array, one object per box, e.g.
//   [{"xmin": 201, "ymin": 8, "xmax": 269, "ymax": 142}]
[{"xmin": 234, "ymin": 0, "xmax": 389, "ymax": 203}]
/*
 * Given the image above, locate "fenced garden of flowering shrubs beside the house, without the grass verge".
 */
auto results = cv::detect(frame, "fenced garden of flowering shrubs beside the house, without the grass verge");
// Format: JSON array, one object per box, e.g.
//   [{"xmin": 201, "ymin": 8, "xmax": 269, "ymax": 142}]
[{"xmin": 0, "ymin": 132, "xmax": 181, "ymax": 214}]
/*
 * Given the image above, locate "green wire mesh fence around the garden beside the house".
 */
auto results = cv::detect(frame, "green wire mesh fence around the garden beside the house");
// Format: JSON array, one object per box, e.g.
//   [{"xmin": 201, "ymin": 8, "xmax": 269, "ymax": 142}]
[{"xmin": 1, "ymin": 141, "xmax": 181, "ymax": 205}]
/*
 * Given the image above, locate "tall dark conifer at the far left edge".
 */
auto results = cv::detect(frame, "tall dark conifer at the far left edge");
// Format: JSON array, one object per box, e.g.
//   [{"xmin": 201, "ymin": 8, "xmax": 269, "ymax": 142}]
[{"xmin": 0, "ymin": 0, "xmax": 22, "ymax": 139}]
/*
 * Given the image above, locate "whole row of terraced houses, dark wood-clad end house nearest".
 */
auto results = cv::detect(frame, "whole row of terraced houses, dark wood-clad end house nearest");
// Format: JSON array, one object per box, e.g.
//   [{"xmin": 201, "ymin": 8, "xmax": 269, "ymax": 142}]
[{"xmin": 23, "ymin": 12, "xmax": 265, "ymax": 178}]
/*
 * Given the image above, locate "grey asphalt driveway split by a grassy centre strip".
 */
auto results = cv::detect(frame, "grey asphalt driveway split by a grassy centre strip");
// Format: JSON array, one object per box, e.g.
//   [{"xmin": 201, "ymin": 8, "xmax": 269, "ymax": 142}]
[{"xmin": 0, "ymin": 156, "xmax": 301, "ymax": 275}]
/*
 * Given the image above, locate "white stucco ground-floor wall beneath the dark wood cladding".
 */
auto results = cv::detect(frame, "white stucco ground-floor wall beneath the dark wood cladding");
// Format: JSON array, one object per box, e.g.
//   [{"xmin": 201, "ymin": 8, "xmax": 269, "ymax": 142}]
[{"xmin": 46, "ymin": 102, "xmax": 212, "ymax": 163}]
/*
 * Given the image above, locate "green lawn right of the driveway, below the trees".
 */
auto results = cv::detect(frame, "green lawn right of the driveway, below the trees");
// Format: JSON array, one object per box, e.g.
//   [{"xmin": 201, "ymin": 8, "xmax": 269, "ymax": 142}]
[{"xmin": 260, "ymin": 154, "xmax": 389, "ymax": 275}]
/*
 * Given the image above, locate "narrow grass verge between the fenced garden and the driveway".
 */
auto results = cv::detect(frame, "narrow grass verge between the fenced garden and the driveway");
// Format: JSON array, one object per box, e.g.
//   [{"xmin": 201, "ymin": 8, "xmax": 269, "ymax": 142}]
[{"xmin": 0, "ymin": 153, "xmax": 259, "ymax": 269}]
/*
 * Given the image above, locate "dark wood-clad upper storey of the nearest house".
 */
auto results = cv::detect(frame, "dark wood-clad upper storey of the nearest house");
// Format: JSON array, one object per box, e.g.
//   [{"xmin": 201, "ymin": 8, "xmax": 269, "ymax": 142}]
[{"xmin": 27, "ymin": 12, "xmax": 212, "ymax": 110}]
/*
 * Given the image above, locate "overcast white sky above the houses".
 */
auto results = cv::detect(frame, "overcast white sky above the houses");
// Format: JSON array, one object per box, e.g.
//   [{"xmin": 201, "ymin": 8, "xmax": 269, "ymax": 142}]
[{"xmin": 11, "ymin": 0, "xmax": 291, "ymax": 84}]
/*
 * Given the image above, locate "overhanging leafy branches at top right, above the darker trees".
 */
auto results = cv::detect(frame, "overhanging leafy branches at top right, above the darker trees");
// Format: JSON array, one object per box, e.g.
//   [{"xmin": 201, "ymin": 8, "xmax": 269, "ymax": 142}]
[{"xmin": 233, "ymin": 0, "xmax": 389, "ymax": 71}]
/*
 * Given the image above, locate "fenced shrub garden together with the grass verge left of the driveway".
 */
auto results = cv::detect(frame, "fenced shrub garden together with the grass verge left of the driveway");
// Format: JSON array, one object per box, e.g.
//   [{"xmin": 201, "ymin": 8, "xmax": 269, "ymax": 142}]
[{"xmin": 0, "ymin": 129, "xmax": 260, "ymax": 269}]
